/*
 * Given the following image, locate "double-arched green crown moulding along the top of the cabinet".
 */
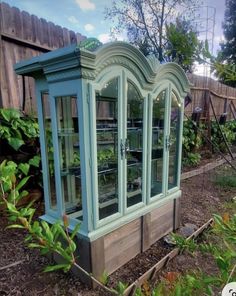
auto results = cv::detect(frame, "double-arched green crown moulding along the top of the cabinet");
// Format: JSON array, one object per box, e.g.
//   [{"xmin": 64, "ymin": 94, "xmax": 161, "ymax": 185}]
[{"xmin": 15, "ymin": 41, "xmax": 189, "ymax": 96}]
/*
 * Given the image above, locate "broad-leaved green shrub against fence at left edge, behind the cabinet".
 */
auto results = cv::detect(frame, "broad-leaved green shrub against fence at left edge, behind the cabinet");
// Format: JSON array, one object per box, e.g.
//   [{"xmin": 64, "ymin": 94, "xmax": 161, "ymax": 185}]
[{"xmin": 0, "ymin": 109, "xmax": 39, "ymax": 150}]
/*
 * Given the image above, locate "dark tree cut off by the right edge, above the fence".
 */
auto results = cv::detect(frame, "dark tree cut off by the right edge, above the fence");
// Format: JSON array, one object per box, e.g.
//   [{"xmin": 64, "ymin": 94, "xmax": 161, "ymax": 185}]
[{"xmin": 216, "ymin": 0, "xmax": 236, "ymax": 87}]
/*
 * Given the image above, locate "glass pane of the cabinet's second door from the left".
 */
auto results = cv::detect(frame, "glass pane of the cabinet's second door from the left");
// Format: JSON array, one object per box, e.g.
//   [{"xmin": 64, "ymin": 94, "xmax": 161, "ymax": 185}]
[{"xmin": 125, "ymin": 81, "xmax": 143, "ymax": 207}]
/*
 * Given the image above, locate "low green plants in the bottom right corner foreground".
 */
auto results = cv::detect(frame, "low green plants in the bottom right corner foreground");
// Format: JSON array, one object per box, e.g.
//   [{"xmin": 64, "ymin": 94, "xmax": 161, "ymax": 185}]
[{"xmin": 152, "ymin": 214, "xmax": 236, "ymax": 296}]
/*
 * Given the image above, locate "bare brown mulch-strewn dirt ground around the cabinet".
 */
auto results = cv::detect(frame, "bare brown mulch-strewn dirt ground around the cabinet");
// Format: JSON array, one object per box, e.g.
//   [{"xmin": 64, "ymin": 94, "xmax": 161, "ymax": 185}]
[{"xmin": 0, "ymin": 160, "xmax": 236, "ymax": 296}]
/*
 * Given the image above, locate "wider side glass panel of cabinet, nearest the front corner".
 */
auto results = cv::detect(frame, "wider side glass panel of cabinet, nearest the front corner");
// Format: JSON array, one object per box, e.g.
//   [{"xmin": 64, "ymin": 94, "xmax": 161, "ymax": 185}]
[{"xmin": 56, "ymin": 96, "xmax": 82, "ymax": 220}]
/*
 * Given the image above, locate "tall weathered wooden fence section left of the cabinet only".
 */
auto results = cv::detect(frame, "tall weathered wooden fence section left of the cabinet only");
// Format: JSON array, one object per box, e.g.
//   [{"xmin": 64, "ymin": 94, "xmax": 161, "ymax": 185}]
[{"xmin": 0, "ymin": 3, "xmax": 86, "ymax": 113}]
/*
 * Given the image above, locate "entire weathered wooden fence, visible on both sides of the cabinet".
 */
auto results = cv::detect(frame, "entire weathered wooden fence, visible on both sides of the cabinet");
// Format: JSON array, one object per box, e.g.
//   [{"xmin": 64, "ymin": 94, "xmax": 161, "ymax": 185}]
[{"xmin": 0, "ymin": 3, "xmax": 236, "ymax": 120}]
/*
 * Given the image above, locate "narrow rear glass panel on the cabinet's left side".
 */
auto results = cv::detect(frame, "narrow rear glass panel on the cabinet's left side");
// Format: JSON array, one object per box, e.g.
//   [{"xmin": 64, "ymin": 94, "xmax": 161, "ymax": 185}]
[{"xmin": 42, "ymin": 93, "xmax": 57, "ymax": 210}]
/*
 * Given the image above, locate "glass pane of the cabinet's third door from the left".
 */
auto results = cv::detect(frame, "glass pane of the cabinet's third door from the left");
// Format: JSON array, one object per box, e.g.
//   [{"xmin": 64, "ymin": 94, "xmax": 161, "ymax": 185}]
[{"xmin": 151, "ymin": 90, "xmax": 166, "ymax": 197}]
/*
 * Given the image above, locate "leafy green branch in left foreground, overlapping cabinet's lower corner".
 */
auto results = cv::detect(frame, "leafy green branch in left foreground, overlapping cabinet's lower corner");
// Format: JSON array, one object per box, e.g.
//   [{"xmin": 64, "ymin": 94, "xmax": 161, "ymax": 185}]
[{"xmin": 0, "ymin": 160, "xmax": 79, "ymax": 271}]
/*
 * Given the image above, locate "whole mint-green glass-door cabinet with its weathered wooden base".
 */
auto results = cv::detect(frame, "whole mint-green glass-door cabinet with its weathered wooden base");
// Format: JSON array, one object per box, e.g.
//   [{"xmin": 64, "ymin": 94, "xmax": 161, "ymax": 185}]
[{"xmin": 15, "ymin": 42, "xmax": 189, "ymax": 275}]
